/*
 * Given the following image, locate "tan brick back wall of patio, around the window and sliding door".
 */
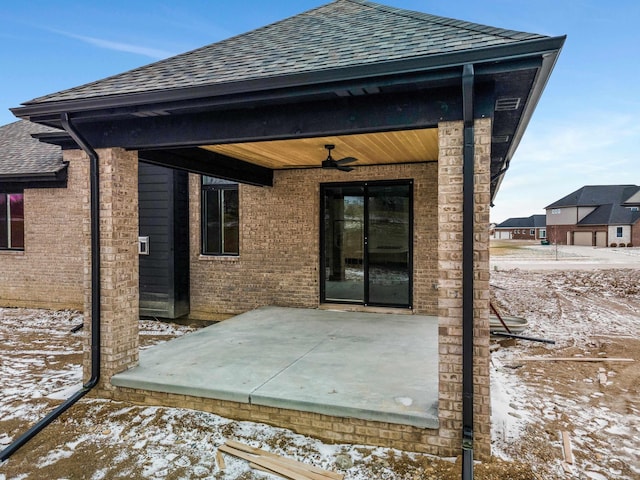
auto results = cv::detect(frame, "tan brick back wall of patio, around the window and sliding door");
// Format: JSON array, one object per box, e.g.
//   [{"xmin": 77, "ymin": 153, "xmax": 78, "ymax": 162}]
[{"xmin": 190, "ymin": 163, "xmax": 437, "ymax": 319}]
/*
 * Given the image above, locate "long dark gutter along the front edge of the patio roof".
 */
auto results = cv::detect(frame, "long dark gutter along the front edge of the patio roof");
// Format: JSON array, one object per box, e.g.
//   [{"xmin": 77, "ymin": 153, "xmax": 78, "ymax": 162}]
[{"xmin": 10, "ymin": 36, "xmax": 566, "ymax": 126}]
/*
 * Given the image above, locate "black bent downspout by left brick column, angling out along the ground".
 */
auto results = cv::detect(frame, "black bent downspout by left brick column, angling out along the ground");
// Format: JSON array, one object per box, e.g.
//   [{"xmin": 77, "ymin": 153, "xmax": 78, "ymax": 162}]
[{"xmin": 0, "ymin": 113, "xmax": 100, "ymax": 462}]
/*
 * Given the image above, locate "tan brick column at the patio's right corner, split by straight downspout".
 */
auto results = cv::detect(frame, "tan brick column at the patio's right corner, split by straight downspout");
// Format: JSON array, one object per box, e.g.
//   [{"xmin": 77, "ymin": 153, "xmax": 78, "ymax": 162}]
[{"xmin": 438, "ymin": 119, "xmax": 491, "ymax": 459}]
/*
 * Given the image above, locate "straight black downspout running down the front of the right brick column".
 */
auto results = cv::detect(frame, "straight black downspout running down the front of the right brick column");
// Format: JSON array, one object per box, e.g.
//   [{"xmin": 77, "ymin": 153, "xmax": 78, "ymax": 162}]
[{"xmin": 462, "ymin": 64, "xmax": 475, "ymax": 480}]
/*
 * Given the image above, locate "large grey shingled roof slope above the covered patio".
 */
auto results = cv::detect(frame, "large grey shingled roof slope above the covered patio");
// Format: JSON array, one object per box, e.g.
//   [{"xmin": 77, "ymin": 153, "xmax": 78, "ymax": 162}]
[{"xmin": 25, "ymin": 0, "xmax": 549, "ymax": 105}]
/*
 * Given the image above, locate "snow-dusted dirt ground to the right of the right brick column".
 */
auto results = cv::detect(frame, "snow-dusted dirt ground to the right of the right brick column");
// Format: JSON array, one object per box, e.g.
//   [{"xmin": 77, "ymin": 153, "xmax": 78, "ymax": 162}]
[{"xmin": 491, "ymin": 242, "xmax": 640, "ymax": 480}]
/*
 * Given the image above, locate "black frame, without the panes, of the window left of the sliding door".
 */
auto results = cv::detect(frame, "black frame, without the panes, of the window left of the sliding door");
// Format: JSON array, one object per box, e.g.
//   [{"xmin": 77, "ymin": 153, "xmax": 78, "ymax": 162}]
[{"xmin": 200, "ymin": 175, "xmax": 240, "ymax": 257}]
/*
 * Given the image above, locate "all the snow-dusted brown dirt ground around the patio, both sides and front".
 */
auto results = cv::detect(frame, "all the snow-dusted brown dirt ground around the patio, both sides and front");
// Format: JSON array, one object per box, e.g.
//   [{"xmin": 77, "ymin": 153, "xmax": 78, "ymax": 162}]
[{"xmin": 0, "ymin": 246, "xmax": 640, "ymax": 480}]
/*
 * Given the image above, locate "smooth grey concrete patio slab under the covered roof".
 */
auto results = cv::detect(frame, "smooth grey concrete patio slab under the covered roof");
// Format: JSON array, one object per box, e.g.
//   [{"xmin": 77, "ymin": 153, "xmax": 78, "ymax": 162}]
[{"xmin": 111, "ymin": 307, "xmax": 438, "ymax": 428}]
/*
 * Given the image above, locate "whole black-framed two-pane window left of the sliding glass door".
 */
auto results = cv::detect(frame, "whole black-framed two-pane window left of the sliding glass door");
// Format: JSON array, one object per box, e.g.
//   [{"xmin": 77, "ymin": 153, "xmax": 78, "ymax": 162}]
[{"xmin": 202, "ymin": 176, "xmax": 240, "ymax": 255}]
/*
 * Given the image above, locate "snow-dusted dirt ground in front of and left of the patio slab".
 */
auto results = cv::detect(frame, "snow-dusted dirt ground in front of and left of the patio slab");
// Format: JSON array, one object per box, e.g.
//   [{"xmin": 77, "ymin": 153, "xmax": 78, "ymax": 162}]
[{"xmin": 0, "ymin": 308, "xmax": 459, "ymax": 480}]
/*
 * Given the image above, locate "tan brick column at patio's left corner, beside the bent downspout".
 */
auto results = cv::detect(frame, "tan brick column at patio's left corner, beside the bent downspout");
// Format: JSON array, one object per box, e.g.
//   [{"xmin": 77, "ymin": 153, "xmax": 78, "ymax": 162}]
[{"xmin": 79, "ymin": 148, "xmax": 139, "ymax": 396}]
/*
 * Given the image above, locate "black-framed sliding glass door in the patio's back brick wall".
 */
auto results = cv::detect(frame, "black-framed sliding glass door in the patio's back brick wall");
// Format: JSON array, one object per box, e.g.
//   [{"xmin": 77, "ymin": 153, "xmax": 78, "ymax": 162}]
[{"xmin": 321, "ymin": 182, "xmax": 412, "ymax": 307}]
